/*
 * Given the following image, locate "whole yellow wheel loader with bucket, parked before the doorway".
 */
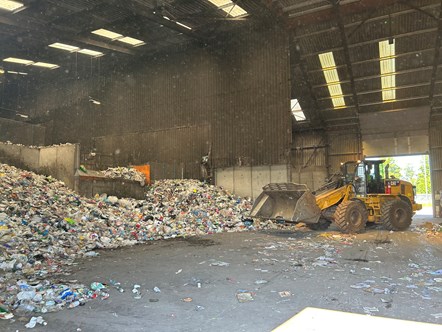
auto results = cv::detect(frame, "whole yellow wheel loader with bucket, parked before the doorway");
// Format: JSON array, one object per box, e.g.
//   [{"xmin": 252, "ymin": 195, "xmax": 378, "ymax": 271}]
[{"xmin": 250, "ymin": 160, "xmax": 422, "ymax": 233}]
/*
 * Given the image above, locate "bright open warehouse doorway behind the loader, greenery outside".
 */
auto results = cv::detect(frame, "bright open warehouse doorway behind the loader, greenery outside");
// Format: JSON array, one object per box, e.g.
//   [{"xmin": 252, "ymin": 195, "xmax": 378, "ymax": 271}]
[{"xmin": 367, "ymin": 154, "xmax": 433, "ymax": 216}]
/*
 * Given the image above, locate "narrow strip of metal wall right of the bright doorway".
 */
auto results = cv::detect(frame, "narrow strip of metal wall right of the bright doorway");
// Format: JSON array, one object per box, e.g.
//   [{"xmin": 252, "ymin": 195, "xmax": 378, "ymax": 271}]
[{"xmin": 430, "ymin": 119, "xmax": 442, "ymax": 217}]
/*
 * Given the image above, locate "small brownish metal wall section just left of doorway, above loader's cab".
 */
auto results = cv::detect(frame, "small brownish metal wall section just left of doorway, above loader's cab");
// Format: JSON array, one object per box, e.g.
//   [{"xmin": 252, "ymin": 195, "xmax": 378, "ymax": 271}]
[{"xmin": 327, "ymin": 128, "xmax": 362, "ymax": 174}]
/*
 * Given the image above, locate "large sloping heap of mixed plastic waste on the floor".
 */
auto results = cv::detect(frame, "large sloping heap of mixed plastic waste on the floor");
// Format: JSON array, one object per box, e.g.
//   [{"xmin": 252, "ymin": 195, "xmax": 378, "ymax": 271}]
[{"xmin": 0, "ymin": 164, "xmax": 254, "ymax": 318}]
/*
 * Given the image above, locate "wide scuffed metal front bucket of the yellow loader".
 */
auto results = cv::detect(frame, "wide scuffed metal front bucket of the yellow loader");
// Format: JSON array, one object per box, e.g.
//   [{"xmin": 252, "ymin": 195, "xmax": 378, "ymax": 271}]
[{"xmin": 250, "ymin": 183, "xmax": 321, "ymax": 224}]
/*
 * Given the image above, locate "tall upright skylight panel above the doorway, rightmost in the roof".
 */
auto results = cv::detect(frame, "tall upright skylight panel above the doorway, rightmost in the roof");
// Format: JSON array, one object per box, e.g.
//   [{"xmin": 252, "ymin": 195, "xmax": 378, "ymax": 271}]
[{"xmin": 379, "ymin": 40, "xmax": 396, "ymax": 101}]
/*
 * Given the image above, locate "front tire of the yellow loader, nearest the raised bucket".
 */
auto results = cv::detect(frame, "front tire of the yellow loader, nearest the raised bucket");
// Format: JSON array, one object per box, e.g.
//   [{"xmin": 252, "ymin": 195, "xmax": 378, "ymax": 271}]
[{"xmin": 334, "ymin": 201, "xmax": 368, "ymax": 233}]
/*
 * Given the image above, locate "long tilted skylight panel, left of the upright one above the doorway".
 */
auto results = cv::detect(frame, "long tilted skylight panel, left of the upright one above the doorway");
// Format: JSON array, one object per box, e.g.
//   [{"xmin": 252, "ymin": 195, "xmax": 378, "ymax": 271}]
[{"xmin": 319, "ymin": 52, "xmax": 346, "ymax": 109}]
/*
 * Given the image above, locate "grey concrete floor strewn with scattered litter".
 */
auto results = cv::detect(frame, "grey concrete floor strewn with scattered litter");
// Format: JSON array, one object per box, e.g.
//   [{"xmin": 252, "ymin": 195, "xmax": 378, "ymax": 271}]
[{"xmin": 0, "ymin": 216, "xmax": 442, "ymax": 332}]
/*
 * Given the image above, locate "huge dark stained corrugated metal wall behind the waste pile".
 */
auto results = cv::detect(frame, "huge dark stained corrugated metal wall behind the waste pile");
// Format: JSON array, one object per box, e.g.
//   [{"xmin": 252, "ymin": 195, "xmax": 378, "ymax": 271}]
[{"xmin": 12, "ymin": 26, "xmax": 291, "ymax": 176}]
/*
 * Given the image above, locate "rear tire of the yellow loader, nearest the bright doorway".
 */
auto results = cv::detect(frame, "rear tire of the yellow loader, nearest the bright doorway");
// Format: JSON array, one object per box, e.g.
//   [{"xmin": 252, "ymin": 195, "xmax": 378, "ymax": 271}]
[{"xmin": 381, "ymin": 199, "xmax": 413, "ymax": 231}]
